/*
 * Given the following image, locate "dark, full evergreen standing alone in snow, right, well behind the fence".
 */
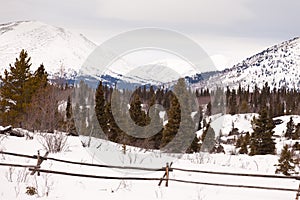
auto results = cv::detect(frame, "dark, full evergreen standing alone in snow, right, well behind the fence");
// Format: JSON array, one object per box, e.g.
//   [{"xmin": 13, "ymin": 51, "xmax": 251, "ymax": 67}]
[{"xmin": 250, "ymin": 109, "xmax": 275, "ymax": 155}]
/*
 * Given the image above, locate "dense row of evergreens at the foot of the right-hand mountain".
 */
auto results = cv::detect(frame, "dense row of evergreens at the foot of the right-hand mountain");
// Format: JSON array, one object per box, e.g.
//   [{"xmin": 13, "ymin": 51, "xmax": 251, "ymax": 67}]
[{"xmin": 196, "ymin": 82, "xmax": 300, "ymax": 118}]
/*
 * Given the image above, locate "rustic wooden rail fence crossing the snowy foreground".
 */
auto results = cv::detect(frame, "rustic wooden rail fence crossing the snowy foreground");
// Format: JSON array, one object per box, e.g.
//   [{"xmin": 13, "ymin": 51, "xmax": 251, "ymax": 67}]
[{"xmin": 0, "ymin": 151, "xmax": 300, "ymax": 195}]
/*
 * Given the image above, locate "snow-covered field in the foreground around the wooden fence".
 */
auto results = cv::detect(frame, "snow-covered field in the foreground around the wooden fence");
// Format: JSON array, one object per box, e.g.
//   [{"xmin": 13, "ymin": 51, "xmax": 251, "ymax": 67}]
[{"xmin": 0, "ymin": 114, "xmax": 300, "ymax": 200}]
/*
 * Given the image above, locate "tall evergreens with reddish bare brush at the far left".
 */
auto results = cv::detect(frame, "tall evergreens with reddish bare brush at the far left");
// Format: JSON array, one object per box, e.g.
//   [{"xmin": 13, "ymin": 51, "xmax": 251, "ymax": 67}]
[{"xmin": 0, "ymin": 50, "xmax": 74, "ymax": 131}]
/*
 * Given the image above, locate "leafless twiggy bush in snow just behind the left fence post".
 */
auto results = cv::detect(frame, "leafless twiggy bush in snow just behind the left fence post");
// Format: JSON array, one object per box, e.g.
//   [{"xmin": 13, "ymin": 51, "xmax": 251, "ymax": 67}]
[{"xmin": 39, "ymin": 133, "xmax": 67, "ymax": 153}]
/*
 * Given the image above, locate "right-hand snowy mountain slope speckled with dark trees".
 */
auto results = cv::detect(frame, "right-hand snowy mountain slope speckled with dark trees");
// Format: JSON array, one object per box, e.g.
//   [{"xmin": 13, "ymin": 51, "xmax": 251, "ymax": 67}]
[{"xmin": 197, "ymin": 38, "xmax": 300, "ymax": 89}]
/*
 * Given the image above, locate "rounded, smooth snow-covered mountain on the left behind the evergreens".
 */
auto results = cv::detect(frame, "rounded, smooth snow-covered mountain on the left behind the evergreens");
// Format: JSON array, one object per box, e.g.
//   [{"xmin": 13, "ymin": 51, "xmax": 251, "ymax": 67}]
[{"xmin": 0, "ymin": 21, "xmax": 96, "ymax": 78}]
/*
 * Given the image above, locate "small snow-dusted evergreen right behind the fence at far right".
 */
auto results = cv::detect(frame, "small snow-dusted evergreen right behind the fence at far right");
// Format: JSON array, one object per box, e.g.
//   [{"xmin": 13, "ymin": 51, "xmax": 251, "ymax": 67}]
[{"xmin": 275, "ymin": 145, "xmax": 295, "ymax": 176}]
